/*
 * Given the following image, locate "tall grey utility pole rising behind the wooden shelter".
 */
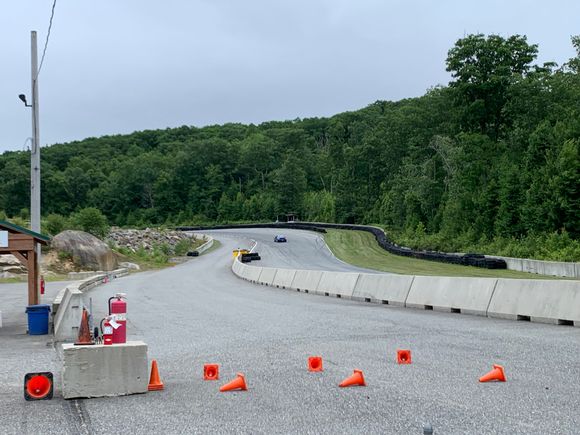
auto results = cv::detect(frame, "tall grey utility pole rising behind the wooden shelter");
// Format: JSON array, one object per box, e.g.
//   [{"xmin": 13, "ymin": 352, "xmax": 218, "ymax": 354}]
[{"xmin": 30, "ymin": 30, "xmax": 40, "ymax": 304}]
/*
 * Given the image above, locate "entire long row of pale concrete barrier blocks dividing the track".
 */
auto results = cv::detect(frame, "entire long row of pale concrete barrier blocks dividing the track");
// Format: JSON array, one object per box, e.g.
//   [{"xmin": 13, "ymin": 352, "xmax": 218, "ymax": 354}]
[{"xmin": 232, "ymin": 259, "xmax": 580, "ymax": 327}]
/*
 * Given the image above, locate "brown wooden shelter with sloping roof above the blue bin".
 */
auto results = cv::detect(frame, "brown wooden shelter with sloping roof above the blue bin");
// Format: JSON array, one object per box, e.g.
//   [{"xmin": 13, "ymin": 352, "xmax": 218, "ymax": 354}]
[{"xmin": 0, "ymin": 220, "xmax": 50, "ymax": 305}]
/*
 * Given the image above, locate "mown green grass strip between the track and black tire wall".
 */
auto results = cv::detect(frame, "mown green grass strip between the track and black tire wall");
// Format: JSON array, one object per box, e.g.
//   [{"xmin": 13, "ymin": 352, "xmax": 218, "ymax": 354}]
[{"xmin": 324, "ymin": 229, "xmax": 557, "ymax": 279}]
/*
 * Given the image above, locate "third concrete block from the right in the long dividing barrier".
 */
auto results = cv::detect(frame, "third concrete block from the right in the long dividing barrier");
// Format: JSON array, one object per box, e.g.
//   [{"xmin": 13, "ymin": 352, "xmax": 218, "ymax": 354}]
[{"xmin": 352, "ymin": 273, "xmax": 415, "ymax": 307}]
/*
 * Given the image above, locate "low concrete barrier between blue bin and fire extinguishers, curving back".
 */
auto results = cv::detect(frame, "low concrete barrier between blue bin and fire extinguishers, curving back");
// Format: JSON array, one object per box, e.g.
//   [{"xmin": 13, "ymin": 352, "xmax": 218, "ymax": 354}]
[{"xmin": 52, "ymin": 269, "xmax": 129, "ymax": 341}]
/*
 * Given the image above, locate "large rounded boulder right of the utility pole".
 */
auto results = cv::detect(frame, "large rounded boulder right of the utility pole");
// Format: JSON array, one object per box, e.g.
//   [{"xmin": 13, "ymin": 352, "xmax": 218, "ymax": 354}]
[{"xmin": 51, "ymin": 230, "xmax": 117, "ymax": 271}]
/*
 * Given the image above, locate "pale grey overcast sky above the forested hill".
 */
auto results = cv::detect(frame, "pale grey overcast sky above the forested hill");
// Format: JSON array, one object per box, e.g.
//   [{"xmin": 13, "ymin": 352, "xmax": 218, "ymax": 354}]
[{"xmin": 0, "ymin": 0, "xmax": 580, "ymax": 152}]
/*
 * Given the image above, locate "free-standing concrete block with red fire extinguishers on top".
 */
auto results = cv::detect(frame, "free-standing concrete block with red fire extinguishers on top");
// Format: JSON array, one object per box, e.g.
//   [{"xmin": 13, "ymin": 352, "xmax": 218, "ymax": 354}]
[{"xmin": 62, "ymin": 341, "xmax": 149, "ymax": 399}]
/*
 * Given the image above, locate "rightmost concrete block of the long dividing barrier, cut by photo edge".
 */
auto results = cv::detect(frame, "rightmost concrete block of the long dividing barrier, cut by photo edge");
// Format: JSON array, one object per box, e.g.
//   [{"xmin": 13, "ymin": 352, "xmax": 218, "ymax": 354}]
[{"xmin": 487, "ymin": 279, "xmax": 580, "ymax": 326}]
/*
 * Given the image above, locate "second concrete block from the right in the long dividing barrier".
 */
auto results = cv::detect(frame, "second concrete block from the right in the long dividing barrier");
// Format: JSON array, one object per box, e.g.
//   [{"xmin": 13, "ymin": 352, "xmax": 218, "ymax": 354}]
[{"xmin": 405, "ymin": 276, "xmax": 497, "ymax": 316}]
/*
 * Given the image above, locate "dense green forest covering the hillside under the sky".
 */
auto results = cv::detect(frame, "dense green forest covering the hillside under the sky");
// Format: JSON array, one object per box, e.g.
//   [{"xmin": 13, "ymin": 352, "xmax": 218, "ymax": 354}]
[{"xmin": 0, "ymin": 34, "xmax": 580, "ymax": 261}]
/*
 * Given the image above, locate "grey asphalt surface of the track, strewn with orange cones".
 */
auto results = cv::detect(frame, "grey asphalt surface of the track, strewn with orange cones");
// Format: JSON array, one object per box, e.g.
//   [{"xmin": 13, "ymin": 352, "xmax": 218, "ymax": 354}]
[{"xmin": 0, "ymin": 230, "xmax": 580, "ymax": 434}]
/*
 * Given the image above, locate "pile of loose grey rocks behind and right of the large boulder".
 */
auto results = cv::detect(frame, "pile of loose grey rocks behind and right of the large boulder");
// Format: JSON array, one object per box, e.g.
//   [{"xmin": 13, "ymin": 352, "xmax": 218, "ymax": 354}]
[{"xmin": 107, "ymin": 228, "xmax": 194, "ymax": 253}]
